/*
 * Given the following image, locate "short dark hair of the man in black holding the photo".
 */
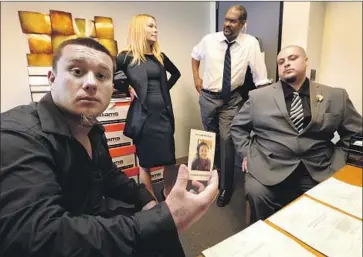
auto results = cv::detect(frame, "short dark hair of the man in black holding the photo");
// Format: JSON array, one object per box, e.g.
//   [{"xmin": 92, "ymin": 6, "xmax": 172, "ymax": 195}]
[{"xmin": 52, "ymin": 37, "xmax": 115, "ymax": 71}]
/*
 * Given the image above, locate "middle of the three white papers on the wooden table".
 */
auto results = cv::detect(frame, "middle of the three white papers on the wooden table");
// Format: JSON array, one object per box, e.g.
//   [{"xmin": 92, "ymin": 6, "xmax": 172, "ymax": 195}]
[{"xmin": 268, "ymin": 196, "xmax": 362, "ymax": 257}]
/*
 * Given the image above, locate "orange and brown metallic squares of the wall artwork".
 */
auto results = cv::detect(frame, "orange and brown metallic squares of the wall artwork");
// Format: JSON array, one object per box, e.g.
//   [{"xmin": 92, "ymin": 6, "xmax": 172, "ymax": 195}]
[{"xmin": 18, "ymin": 10, "xmax": 118, "ymax": 67}]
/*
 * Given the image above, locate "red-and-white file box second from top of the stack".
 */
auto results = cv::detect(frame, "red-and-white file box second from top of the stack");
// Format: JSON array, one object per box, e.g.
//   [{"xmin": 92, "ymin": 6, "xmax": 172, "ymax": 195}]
[{"xmin": 103, "ymin": 123, "xmax": 132, "ymax": 148}]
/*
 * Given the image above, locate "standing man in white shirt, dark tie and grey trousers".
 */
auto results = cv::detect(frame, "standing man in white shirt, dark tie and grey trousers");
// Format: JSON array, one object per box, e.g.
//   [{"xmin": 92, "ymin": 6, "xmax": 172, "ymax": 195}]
[{"xmin": 192, "ymin": 5, "xmax": 270, "ymax": 207}]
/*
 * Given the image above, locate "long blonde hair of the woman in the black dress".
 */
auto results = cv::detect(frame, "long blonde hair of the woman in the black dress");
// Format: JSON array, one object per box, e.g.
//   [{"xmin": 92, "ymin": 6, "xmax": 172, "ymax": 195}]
[{"xmin": 126, "ymin": 14, "xmax": 163, "ymax": 65}]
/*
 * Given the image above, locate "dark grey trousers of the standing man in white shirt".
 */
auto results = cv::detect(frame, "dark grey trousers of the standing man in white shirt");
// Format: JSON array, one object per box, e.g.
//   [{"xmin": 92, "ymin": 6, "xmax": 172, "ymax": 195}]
[{"xmin": 199, "ymin": 90, "xmax": 243, "ymax": 192}]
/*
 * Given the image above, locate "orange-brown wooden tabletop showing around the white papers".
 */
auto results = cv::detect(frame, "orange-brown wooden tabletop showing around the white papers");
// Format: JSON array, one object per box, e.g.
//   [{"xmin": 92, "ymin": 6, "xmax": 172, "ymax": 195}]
[{"xmin": 198, "ymin": 165, "xmax": 363, "ymax": 257}]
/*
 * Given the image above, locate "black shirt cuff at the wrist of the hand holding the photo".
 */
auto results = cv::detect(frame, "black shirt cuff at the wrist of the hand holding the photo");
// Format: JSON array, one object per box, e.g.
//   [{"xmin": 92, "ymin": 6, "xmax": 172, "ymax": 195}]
[{"xmin": 135, "ymin": 202, "xmax": 184, "ymax": 256}]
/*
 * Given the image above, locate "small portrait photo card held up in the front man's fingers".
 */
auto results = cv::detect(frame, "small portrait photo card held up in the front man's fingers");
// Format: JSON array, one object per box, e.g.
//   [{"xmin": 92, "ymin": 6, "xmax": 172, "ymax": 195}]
[{"xmin": 188, "ymin": 129, "xmax": 216, "ymax": 181}]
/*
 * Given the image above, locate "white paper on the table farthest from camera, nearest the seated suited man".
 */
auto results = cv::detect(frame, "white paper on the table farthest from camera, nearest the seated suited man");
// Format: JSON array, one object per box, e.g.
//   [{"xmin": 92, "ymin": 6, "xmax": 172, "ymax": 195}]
[{"xmin": 306, "ymin": 178, "xmax": 362, "ymax": 219}]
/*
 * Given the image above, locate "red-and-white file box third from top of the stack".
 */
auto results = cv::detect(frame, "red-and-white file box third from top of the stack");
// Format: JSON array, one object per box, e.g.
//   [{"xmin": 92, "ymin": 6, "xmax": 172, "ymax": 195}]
[{"xmin": 109, "ymin": 145, "xmax": 136, "ymax": 170}]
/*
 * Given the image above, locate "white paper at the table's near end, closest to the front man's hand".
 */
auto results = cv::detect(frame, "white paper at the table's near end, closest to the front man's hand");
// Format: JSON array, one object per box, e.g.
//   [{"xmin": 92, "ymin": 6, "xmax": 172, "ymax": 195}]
[{"xmin": 203, "ymin": 220, "xmax": 315, "ymax": 257}]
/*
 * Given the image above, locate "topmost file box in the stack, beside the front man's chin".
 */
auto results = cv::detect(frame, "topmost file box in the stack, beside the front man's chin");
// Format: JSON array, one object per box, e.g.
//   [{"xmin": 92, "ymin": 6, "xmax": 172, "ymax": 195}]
[{"xmin": 97, "ymin": 99, "xmax": 130, "ymax": 124}]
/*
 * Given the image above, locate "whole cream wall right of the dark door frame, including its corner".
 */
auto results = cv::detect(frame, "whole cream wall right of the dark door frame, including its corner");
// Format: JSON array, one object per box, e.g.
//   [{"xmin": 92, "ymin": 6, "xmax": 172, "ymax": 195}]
[{"xmin": 281, "ymin": 2, "xmax": 362, "ymax": 113}]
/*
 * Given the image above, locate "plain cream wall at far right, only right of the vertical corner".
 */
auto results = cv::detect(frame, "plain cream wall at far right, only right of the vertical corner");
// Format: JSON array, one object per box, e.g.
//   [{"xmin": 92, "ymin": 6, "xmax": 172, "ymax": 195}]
[{"xmin": 318, "ymin": 2, "xmax": 362, "ymax": 114}]
